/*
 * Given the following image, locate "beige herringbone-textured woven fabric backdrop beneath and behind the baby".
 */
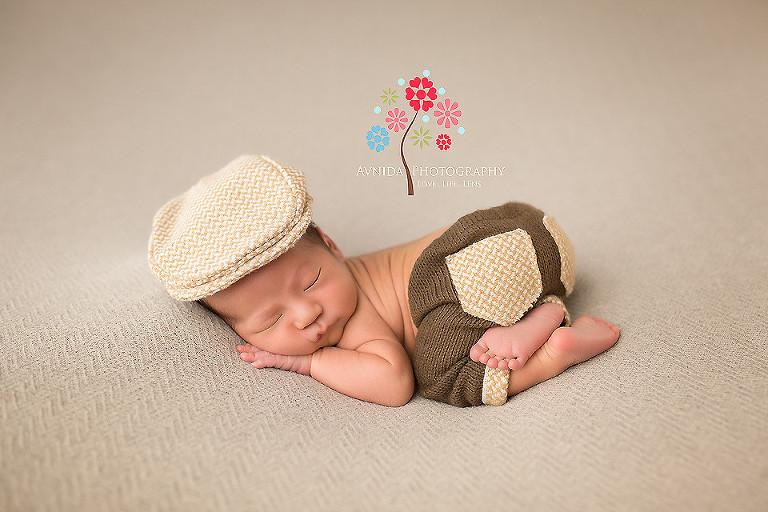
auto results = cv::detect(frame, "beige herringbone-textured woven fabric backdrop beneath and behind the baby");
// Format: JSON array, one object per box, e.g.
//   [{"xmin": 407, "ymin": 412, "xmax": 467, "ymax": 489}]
[{"xmin": 0, "ymin": 0, "xmax": 768, "ymax": 512}]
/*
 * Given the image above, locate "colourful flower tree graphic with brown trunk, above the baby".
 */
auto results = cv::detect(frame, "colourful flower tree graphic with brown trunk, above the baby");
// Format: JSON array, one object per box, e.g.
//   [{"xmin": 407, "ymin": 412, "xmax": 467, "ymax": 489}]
[{"xmin": 365, "ymin": 69, "xmax": 466, "ymax": 196}]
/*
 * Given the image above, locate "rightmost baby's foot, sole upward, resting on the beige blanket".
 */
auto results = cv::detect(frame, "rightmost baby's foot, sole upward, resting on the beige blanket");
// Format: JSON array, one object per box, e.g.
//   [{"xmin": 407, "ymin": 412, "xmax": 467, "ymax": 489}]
[{"xmin": 547, "ymin": 315, "xmax": 620, "ymax": 366}]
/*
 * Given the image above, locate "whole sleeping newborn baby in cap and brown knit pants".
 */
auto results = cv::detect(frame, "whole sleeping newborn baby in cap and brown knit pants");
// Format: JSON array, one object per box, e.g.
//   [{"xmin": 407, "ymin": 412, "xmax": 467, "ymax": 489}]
[{"xmin": 149, "ymin": 156, "xmax": 619, "ymax": 407}]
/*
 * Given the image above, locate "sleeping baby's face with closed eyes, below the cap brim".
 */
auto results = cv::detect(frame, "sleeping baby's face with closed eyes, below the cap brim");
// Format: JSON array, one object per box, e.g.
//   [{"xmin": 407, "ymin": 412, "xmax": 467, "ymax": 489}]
[{"xmin": 206, "ymin": 236, "xmax": 357, "ymax": 355}]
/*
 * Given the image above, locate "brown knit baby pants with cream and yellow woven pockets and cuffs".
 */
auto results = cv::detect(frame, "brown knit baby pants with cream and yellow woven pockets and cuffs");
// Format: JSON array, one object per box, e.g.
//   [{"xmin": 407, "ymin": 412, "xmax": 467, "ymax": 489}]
[{"xmin": 408, "ymin": 203, "xmax": 575, "ymax": 407}]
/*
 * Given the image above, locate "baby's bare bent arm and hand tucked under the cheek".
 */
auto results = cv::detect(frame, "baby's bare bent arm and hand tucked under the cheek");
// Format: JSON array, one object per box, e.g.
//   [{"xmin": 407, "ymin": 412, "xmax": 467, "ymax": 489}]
[{"xmin": 237, "ymin": 339, "xmax": 414, "ymax": 407}]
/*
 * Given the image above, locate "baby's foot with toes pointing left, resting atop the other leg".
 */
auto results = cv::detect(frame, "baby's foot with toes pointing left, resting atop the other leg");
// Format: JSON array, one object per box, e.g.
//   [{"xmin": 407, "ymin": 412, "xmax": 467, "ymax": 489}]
[{"xmin": 469, "ymin": 303, "xmax": 563, "ymax": 370}]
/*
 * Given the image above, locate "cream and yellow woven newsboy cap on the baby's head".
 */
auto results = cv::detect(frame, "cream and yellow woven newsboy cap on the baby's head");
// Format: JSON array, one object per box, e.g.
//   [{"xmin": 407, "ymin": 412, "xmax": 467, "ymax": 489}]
[{"xmin": 149, "ymin": 155, "xmax": 312, "ymax": 300}]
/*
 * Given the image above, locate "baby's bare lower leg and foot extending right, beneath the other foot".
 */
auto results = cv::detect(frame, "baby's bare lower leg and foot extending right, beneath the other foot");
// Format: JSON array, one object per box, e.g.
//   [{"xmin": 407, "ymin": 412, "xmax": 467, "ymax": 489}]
[{"xmin": 507, "ymin": 315, "xmax": 619, "ymax": 395}]
